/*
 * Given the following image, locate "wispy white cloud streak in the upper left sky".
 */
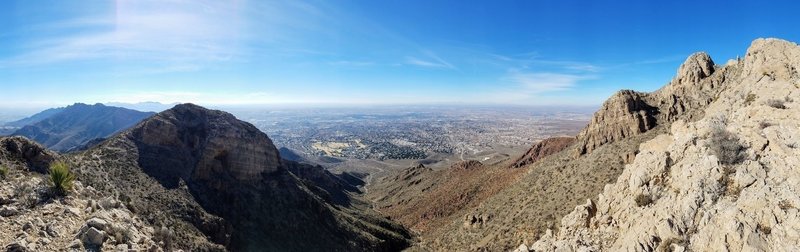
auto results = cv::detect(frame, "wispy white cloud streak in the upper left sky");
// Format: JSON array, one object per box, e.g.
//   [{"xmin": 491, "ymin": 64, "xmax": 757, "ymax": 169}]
[{"xmin": 0, "ymin": 0, "xmax": 253, "ymax": 70}]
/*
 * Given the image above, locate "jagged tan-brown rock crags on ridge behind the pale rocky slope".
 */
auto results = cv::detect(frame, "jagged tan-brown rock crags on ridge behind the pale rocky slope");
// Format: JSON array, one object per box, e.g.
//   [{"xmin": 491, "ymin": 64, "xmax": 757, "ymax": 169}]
[{"xmin": 577, "ymin": 52, "xmax": 737, "ymax": 155}]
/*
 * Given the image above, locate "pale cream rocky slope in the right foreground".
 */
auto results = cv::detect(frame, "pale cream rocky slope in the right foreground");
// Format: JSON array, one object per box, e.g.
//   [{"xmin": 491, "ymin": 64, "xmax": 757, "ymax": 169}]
[{"xmin": 521, "ymin": 39, "xmax": 800, "ymax": 251}]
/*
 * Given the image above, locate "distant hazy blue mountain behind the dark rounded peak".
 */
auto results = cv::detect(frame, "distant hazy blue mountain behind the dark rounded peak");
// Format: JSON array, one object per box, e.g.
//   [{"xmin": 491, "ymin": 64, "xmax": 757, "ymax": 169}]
[{"xmin": 12, "ymin": 103, "xmax": 153, "ymax": 151}]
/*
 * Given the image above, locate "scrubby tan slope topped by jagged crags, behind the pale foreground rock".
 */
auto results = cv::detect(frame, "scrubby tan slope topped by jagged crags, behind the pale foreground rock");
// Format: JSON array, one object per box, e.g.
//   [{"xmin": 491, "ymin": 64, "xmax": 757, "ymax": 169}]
[{"xmin": 417, "ymin": 40, "xmax": 752, "ymax": 251}]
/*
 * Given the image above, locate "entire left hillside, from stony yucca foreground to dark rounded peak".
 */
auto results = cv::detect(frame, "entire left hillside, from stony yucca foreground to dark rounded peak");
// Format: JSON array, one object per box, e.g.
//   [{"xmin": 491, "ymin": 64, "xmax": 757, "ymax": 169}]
[{"xmin": 0, "ymin": 104, "xmax": 410, "ymax": 251}]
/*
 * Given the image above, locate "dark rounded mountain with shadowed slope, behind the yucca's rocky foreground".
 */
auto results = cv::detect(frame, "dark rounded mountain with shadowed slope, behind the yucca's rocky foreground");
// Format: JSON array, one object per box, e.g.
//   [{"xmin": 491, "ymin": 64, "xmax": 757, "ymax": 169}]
[{"xmin": 74, "ymin": 104, "xmax": 409, "ymax": 251}]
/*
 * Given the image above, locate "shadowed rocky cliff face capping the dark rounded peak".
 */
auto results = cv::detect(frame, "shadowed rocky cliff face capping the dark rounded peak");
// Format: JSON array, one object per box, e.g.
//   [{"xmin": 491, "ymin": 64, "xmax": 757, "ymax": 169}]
[{"xmin": 123, "ymin": 104, "xmax": 281, "ymax": 190}]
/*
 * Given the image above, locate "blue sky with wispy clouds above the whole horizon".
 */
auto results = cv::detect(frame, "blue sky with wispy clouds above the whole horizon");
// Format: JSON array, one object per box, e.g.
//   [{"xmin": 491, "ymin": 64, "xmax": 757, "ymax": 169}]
[{"xmin": 0, "ymin": 0, "xmax": 800, "ymax": 108}]
